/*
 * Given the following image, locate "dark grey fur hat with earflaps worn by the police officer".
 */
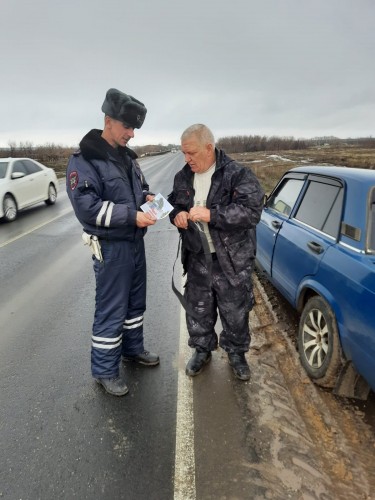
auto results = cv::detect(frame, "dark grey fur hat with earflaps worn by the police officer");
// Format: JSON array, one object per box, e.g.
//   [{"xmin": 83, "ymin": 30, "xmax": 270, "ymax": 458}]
[{"xmin": 102, "ymin": 89, "xmax": 147, "ymax": 128}]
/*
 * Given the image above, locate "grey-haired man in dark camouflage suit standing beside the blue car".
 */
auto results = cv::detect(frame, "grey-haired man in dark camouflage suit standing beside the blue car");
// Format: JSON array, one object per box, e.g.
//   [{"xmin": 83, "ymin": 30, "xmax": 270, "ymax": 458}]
[{"xmin": 169, "ymin": 124, "xmax": 264, "ymax": 380}]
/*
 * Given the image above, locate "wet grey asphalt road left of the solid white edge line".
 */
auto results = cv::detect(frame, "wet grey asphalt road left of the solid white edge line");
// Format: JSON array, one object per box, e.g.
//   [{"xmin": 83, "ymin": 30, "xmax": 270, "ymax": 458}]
[{"xmin": 0, "ymin": 155, "xmax": 182, "ymax": 500}]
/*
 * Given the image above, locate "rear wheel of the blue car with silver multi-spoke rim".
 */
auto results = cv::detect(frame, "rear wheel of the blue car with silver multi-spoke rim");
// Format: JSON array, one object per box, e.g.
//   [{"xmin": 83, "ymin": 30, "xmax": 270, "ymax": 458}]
[{"xmin": 298, "ymin": 295, "xmax": 342, "ymax": 387}]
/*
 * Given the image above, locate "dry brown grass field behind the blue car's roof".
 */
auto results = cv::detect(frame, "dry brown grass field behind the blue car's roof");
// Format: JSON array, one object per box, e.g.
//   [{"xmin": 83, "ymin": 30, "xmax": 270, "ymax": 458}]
[{"xmin": 229, "ymin": 146, "xmax": 375, "ymax": 193}]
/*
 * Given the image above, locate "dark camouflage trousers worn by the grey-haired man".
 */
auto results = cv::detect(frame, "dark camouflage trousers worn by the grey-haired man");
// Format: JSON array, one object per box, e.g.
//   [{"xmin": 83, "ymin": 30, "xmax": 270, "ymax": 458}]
[{"xmin": 184, "ymin": 254, "xmax": 254, "ymax": 353}]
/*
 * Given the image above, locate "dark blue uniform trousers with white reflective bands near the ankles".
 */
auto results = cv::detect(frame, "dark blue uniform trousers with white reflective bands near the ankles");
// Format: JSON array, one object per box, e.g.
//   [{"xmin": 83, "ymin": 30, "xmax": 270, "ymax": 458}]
[{"xmin": 91, "ymin": 238, "xmax": 146, "ymax": 378}]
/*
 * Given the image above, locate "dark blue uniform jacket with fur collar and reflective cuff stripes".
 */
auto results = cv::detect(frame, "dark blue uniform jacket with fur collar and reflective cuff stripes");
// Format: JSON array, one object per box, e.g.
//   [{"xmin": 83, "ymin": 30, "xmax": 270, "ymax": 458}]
[{"xmin": 66, "ymin": 130, "xmax": 149, "ymax": 241}]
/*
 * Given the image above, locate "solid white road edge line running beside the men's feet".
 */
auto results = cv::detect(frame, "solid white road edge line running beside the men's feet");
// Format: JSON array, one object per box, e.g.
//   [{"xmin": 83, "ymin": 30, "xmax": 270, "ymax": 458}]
[{"xmin": 174, "ymin": 308, "xmax": 196, "ymax": 500}]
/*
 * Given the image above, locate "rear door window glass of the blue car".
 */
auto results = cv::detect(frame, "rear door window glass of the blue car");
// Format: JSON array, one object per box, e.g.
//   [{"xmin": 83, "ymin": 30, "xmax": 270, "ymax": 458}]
[{"xmin": 295, "ymin": 181, "xmax": 344, "ymax": 238}]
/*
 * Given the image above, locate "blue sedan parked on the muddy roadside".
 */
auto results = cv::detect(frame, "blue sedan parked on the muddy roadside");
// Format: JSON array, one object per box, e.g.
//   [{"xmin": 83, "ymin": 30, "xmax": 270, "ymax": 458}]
[{"xmin": 256, "ymin": 166, "xmax": 375, "ymax": 399}]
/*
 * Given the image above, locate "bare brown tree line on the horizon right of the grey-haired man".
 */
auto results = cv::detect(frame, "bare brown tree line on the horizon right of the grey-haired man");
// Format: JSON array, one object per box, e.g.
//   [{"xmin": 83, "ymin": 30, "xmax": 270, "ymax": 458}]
[{"xmin": 217, "ymin": 135, "xmax": 375, "ymax": 153}]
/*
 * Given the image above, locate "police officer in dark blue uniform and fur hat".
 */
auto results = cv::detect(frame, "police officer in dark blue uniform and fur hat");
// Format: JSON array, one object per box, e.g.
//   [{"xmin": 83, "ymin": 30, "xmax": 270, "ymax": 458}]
[{"xmin": 66, "ymin": 88, "xmax": 159, "ymax": 396}]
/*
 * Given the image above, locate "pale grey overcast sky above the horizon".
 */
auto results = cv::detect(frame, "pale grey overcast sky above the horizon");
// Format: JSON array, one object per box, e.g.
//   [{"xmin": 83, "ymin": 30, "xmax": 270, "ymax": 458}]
[{"xmin": 0, "ymin": 0, "xmax": 375, "ymax": 147}]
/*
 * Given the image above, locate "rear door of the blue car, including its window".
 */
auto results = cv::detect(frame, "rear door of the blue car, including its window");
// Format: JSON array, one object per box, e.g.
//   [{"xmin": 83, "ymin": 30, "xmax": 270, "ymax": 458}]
[{"xmin": 271, "ymin": 175, "xmax": 344, "ymax": 305}]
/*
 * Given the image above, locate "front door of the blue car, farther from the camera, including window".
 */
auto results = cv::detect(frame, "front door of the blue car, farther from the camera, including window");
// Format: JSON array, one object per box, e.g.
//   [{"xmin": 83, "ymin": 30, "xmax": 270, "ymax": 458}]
[{"xmin": 256, "ymin": 174, "xmax": 307, "ymax": 279}]
